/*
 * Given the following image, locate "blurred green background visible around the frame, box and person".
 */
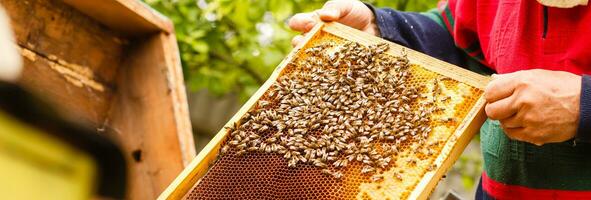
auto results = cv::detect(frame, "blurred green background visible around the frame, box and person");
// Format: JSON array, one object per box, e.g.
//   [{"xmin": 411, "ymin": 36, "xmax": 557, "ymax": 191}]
[{"xmin": 144, "ymin": 0, "xmax": 482, "ymax": 199}]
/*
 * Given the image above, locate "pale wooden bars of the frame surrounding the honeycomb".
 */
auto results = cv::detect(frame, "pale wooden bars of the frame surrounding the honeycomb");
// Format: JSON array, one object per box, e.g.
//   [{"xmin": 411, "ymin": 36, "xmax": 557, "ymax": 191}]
[{"xmin": 158, "ymin": 23, "xmax": 489, "ymax": 200}]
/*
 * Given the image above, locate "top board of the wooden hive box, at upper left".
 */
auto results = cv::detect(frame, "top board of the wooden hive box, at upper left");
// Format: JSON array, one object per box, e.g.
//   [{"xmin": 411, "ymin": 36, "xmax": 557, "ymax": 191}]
[{"xmin": 63, "ymin": 0, "xmax": 174, "ymax": 36}]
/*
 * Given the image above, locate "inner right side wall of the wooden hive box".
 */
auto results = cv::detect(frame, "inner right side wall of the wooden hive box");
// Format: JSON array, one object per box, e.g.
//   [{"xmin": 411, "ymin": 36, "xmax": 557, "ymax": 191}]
[{"xmin": 107, "ymin": 33, "xmax": 190, "ymax": 199}]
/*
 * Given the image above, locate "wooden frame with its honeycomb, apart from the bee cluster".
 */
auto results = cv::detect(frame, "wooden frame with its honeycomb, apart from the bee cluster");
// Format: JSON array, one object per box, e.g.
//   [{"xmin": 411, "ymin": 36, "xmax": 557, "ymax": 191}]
[{"xmin": 159, "ymin": 23, "xmax": 489, "ymax": 199}]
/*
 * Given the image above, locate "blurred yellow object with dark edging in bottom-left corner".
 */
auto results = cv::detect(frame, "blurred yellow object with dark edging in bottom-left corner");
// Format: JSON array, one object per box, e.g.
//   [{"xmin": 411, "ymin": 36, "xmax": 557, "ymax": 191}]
[{"xmin": 0, "ymin": 111, "xmax": 96, "ymax": 200}]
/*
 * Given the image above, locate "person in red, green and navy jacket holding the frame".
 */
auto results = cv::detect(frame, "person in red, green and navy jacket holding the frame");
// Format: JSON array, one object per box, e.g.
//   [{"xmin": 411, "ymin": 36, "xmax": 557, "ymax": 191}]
[{"xmin": 289, "ymin": 0, "xmax": 591, "ymax": 199}]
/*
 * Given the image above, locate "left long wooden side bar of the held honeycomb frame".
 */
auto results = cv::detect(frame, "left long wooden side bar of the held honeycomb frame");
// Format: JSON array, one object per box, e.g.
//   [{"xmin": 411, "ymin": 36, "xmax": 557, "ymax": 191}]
[{"xmin": 158, "ymin": 20, "xmax": 322, "ymax": 200}]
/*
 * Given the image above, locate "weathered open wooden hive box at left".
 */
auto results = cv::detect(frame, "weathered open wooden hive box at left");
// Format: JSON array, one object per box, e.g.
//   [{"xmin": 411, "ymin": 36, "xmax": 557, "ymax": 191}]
[{"xmin": 0, "ymin": 0, "xmax": 195, "ymax": 199}]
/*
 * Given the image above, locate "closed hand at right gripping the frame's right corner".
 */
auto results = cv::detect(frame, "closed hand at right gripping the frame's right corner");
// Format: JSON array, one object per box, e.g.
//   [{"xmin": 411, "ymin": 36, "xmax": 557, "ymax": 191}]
[{"xmin": 484, "ymin": 69, "xmax": 581, "ymax": 145}]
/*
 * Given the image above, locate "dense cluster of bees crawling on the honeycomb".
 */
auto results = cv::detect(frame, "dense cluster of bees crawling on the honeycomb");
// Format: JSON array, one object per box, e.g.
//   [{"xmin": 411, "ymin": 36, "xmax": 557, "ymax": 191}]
[{"xmin": 221, "ymin": 42, "xmax": 436, "ymax": 181}]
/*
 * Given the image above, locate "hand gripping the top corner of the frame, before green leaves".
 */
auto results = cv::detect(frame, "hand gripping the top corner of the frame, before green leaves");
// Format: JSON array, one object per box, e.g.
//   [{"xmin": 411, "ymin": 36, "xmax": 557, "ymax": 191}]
[{"xmin": 288, "ymin": 0, "xmax": 379, "ymax": 46}]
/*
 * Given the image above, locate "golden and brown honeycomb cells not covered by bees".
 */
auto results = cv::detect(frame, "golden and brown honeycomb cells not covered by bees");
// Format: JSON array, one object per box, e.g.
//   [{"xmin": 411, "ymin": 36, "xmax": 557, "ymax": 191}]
[{"xmin": 185, "ymin": 31, "xmax": 482, "ymax": 199}]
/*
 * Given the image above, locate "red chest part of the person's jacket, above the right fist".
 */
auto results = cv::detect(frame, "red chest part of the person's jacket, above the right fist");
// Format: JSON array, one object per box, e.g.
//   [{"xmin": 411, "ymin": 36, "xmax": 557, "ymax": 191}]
[{"xmin": 440, "ymin": 0, "xmax": 591, "ymax": 74}]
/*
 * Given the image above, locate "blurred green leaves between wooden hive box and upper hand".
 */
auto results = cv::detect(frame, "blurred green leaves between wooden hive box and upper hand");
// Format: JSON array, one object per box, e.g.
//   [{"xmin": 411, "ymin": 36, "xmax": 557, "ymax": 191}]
[{"xmin": 144, "ymin": 0, "xmax": 437, "ymax": 101}]
